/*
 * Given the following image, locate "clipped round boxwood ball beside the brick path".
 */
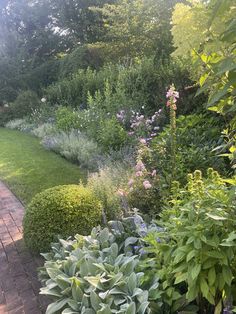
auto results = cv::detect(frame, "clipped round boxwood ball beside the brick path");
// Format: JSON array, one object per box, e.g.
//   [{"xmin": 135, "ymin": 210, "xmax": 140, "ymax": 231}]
[{"xmin": 23, "ymin": 185, "xmax": 102, "ymax": 253}]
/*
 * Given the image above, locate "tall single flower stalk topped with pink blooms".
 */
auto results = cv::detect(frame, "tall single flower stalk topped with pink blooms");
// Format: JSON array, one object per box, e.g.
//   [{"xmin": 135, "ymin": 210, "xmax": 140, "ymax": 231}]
[{"xmin": 166, "ymin": 84, "xmax": 179, "ymax": 180}]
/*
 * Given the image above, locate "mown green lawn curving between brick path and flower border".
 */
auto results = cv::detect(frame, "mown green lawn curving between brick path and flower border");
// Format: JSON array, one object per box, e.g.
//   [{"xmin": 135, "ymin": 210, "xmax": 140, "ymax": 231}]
[{"xmin": 0, "ymin": 128, "xmax": 86, "ymax": 205}]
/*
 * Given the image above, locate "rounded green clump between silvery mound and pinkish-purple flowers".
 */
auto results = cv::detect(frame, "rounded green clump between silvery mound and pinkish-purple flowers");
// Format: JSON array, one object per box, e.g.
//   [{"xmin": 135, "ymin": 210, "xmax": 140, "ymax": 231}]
[{"xmin": 98, "ymin": 117, "xmax": 128, "ymax": 151}]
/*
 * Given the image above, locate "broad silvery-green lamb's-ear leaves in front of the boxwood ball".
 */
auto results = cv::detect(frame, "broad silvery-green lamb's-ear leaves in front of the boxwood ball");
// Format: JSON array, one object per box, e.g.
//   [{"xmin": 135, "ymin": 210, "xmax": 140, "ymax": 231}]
[{"xmin": 40, "ymin": 216, "xmax": 158, "ymax": 314}]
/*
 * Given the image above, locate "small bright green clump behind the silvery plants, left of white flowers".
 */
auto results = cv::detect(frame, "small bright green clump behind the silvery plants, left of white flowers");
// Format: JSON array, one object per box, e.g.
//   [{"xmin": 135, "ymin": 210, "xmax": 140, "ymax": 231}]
[{"xmin": 56, "ymin": 107, "xmax": 79, "ymax": 132}]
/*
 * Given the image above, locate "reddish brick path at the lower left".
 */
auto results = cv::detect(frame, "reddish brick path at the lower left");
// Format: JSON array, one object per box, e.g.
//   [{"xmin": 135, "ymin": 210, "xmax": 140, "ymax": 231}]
[{"xmin": 0, "ymin": 181, "xmax": 47, "ymax": 314}]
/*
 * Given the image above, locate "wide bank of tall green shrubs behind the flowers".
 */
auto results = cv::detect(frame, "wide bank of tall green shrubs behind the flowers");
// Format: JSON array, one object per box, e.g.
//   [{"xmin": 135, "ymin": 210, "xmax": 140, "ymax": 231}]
[{"xmin": 44, "ymin": 59, "xmax": 203, "ymax": 114}]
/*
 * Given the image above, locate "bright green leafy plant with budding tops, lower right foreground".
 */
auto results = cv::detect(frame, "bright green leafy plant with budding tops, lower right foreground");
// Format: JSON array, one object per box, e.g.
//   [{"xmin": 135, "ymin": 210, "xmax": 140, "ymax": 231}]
[{"xmin": 146, "ymin": 168, "xmax": 236, "ymax": 313}]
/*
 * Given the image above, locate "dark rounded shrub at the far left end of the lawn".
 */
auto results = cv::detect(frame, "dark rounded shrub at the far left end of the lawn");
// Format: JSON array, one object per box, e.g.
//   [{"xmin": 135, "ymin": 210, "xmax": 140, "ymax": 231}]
[{"xmin": 11, "ymin": 90, "xmax": 40, "ymax": 118}]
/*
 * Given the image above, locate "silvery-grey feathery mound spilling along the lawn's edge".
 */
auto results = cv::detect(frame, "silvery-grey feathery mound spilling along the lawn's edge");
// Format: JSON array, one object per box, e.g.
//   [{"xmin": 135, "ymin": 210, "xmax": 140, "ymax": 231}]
[{"xmin": 42, "ymin": 131, "xmax": 101, "ymax": 170}]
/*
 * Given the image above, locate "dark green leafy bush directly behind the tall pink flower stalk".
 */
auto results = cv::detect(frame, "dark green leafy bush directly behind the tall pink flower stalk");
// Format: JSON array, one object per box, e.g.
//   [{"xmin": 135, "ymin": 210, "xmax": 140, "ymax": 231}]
[{"xmin": 151, "ymin": 114, "xmax": 229, "ymax": 184}]
